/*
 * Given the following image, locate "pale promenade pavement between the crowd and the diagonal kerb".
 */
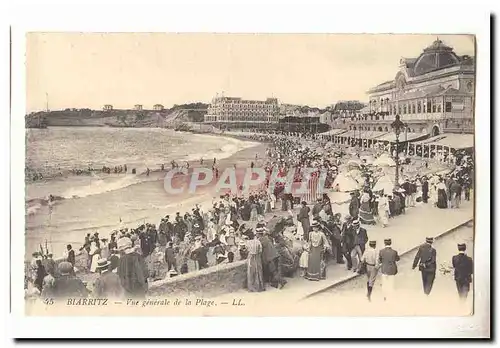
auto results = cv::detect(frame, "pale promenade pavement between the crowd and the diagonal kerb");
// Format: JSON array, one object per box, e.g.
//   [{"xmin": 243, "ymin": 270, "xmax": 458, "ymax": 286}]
[{"xmin": 210, "ymin": 201, "xmax": 474, "ymax": 308}]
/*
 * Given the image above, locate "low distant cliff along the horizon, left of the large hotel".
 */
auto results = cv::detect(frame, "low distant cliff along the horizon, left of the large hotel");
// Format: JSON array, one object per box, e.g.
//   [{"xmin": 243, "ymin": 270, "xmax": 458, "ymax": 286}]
[{"xmin": 25, "ymin": 103, "xmax": 208, "ymax": 128}]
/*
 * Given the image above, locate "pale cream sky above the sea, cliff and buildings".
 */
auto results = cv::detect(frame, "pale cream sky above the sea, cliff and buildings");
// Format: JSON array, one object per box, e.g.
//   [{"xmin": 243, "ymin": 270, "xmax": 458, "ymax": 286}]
[{"xmin": 26, "ymin": 33, "xmax": 474, "ymax": 112}]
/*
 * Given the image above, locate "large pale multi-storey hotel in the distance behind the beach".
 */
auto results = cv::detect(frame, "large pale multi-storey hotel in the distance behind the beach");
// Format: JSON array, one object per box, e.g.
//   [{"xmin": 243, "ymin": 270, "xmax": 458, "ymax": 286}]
[{"xmin": 204, "ymin": 96, "xmax": 280, "ymax": 123}]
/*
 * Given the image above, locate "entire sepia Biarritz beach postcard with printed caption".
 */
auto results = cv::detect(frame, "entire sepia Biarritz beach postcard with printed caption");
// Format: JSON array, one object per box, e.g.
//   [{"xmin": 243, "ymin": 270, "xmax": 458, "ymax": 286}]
[{"xmin": 9, "ymin": 19, "xmax": 489, "ymax": 338}]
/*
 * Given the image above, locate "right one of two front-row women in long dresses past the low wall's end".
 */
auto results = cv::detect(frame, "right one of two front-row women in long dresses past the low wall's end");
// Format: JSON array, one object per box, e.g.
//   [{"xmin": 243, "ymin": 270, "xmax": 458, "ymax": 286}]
[{"xmin": 305, "ymin": 221, "xmax": 329, "ymax": 281}]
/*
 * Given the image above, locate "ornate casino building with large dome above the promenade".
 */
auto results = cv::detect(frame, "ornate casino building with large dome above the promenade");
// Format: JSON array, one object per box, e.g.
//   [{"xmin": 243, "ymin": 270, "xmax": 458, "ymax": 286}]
[{"xmin": 340, "ymin": 39, "xmax": 475, "ymax": 140}]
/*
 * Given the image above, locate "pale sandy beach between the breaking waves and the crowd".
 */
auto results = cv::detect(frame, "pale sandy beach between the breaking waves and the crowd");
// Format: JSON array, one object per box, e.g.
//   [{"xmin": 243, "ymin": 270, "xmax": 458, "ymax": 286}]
[{"xmin": 26, "ymin": 133, "xmax": 268, "ymax": 258}]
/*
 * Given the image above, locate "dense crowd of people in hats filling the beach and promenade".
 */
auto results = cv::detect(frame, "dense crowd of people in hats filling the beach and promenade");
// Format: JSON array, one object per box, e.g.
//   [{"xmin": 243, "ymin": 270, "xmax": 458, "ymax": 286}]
[{"xmin": 26, "ymin": 134, "xmax": 473, "ymax": 297}]
